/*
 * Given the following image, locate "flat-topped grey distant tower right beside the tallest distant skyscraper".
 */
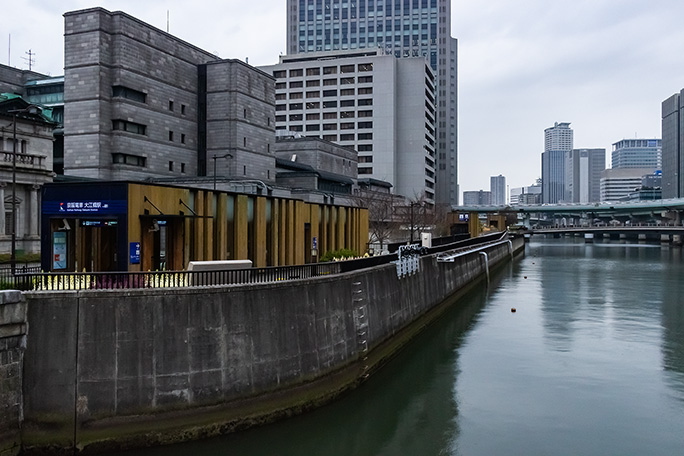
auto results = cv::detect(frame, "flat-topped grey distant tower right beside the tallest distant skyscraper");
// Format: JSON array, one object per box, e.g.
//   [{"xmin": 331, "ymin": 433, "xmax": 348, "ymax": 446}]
[{"xmin": 565, "ymin": 149, "xmax": 606, "ymax": 203}]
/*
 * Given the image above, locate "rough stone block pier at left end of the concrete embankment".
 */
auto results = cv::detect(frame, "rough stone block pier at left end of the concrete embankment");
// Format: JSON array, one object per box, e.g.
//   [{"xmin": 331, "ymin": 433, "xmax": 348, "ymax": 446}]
[{"xmin": 0, "ymin": 291, "xmax": 27, "ymax": 456}]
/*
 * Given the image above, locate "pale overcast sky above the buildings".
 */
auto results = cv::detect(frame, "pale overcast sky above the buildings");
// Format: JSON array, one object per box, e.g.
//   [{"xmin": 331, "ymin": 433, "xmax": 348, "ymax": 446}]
[{"xmin": 5, "ymin": 0, "xmax": 684, "ymax": 200}]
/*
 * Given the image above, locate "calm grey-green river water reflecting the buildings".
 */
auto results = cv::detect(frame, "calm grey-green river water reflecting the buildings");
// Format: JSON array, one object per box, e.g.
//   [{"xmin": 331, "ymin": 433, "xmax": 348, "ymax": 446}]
[{"xmin": 121, "ymin": 239, "xmax": 684, "ymax": 456}]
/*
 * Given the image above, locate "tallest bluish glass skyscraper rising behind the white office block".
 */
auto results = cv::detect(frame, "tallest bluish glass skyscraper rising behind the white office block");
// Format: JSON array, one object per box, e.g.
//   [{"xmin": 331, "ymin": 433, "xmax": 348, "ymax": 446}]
[{"xmin": 287, "ymin": 0, "xmax": 458, "ymax": 204}]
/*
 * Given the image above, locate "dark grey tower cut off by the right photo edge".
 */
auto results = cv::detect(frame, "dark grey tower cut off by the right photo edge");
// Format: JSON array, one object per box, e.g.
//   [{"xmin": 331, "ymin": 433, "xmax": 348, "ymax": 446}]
[{"xmin": 662, "ymin": 90, "xmax": 684, "ymax": 198}]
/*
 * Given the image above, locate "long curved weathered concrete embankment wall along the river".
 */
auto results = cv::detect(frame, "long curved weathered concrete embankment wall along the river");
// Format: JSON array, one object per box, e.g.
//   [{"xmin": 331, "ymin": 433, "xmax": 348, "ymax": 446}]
[{"xmin": 23, "ymin": 235, "xmax": 523, "ymax": 452}]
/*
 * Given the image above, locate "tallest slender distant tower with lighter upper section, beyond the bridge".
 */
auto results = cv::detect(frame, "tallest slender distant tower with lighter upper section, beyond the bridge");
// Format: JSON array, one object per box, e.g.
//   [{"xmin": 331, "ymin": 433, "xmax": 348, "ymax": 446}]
[{"xmin": 542, "ymin": 122, "xmax": 573, "ymax": 204}]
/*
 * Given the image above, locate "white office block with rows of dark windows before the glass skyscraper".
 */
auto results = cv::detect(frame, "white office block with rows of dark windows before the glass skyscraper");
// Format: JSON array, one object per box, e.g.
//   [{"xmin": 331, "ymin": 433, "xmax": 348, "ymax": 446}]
[{"xmin": 261, "ymin": 49, "xmax": 436, "ymax": 203}]
